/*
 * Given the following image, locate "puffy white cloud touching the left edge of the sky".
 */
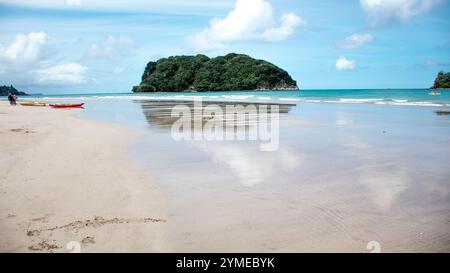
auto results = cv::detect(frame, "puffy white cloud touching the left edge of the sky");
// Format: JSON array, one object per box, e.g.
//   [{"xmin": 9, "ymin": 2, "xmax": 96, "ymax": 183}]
[{"xmin": 0, "ymin": 32, "xmax": 47, "ymax": 63}]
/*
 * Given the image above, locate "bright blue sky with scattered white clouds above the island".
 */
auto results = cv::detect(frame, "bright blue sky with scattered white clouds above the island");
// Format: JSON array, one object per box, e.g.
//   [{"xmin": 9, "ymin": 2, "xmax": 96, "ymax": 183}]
[{"xmin": 0, "ymin": 0, "xmax": 450, "ymax": 94}]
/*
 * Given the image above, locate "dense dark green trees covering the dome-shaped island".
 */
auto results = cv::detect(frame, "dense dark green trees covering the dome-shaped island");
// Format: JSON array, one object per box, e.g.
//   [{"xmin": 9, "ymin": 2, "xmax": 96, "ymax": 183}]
[{"xmin": 133, "ymin": 53, "xmax": 298, "ymax": 92}]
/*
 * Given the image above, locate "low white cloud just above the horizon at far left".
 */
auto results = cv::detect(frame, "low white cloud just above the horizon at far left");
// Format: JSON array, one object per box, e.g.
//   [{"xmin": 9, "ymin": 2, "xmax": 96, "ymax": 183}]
[{"xmin": 36, "ymin": 63, "xmax": 87, "ymax": 84}]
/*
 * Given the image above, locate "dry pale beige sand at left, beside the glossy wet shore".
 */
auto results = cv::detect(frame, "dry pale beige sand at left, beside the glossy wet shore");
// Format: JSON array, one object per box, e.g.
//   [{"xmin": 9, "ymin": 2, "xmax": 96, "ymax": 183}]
[{"xmin": 0, "ymin": 102, "xmax": 166, "ymax": 252}]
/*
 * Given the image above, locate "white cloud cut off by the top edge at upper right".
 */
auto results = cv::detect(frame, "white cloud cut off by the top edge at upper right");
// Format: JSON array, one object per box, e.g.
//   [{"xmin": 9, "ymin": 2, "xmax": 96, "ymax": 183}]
[{"xmin": 360, "ymin": 0, "xmax": 442, "ymax": 25}]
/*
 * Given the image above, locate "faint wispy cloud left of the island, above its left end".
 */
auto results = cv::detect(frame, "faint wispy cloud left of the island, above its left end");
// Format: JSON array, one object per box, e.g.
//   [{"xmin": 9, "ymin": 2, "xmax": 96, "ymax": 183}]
[{"xmin": 85, "ymin": 35, "xmax": 137, "ymax": 59}]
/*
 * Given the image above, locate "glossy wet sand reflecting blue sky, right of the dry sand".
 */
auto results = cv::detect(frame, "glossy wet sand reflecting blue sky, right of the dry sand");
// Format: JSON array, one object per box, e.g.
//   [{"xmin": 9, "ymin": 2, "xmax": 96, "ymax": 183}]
[{"xmin": 15, "ymin": 93, "xmax": 450, "ymax": 252}]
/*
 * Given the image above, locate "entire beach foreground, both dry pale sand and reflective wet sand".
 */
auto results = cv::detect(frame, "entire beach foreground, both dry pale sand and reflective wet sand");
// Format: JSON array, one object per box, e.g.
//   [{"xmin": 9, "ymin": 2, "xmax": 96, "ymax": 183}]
[{"xmin": 0, "ymin": 101, "xmax": 450, "ymax": 252}]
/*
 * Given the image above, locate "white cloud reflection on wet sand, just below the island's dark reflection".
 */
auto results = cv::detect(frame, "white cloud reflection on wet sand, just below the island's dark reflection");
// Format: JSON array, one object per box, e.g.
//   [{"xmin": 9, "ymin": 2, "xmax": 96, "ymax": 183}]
[{"xmin": 198, "ymin": 142, "xmax": 302, "ymax": 186}]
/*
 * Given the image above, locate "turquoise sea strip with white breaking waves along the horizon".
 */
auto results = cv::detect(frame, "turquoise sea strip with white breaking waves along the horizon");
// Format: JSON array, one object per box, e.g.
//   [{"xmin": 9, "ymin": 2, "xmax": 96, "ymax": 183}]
[{"xmin": 8, "ymin": 89, "xmax": 450, "ymax": 107}]
